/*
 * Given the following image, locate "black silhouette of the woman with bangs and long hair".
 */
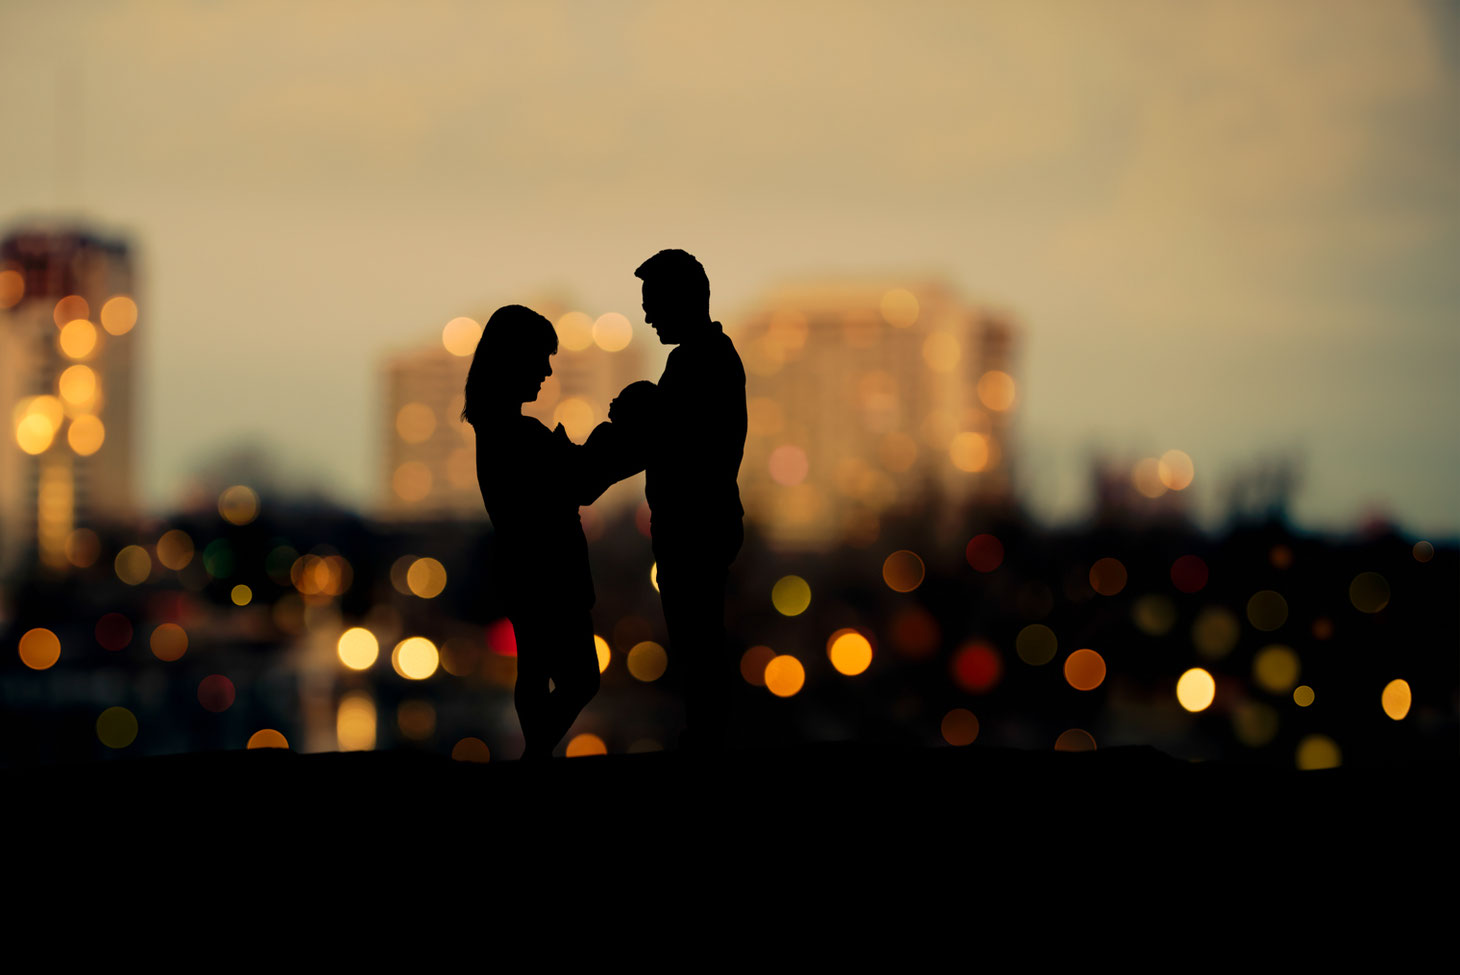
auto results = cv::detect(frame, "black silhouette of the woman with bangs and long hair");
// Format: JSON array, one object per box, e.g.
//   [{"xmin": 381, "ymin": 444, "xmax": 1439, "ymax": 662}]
[{"xmin": 461, "ymin": 305, "xmax": 616, "ymax": 759}]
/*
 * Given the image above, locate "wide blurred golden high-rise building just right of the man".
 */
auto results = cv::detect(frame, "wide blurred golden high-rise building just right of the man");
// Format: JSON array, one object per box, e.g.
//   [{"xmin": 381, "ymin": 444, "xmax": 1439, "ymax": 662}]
[{"xmin": 731, "ymin": 279, "xmax": 1019, "ymax": 549}]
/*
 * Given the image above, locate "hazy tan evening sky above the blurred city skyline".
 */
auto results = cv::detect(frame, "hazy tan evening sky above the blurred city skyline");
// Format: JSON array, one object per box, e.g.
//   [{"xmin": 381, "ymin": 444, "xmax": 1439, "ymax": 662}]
[{"xmin": 0, "ymin": 0, "xmax": 1460, "ymax": 533}]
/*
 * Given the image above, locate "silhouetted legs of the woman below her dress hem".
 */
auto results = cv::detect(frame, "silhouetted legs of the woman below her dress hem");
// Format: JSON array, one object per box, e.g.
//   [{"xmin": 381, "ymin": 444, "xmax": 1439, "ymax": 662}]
[{"xmin": 512, "ymin": 610, "xmax": 599, "ymax": 759}]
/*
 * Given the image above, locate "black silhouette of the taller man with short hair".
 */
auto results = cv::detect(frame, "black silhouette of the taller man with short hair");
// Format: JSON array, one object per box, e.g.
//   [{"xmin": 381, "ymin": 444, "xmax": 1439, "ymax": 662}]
[{"xmin": 610, "ymin": 250, "xmax": 746, "ymax": 752}]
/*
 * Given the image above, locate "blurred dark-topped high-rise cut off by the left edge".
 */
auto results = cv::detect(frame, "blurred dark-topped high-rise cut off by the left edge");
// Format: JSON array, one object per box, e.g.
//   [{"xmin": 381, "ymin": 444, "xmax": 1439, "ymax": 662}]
[{"xmin": 0, "ymin": 228, "xmax": 137, "ymax": 575}]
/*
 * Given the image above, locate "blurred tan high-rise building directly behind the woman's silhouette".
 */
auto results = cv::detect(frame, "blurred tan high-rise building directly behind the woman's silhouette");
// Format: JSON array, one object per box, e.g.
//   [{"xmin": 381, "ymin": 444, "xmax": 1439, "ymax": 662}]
[{"xmin": 381, "ymin": 301, "xmax": 645, "ymax": 520}]
